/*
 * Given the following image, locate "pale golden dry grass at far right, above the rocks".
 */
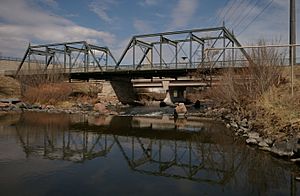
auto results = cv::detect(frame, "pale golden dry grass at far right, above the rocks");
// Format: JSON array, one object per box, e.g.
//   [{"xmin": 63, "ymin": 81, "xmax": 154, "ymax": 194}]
[{"xmin": 255, "ymin": 78, "xmax": 300, "ymax": 135}]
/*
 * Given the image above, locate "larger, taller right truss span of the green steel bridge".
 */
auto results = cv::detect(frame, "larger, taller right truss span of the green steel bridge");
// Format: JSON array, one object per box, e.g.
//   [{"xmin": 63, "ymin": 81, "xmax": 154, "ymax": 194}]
[{"xmin": 116, "ymin": 27, "xmax": 250, "ymax": 70}]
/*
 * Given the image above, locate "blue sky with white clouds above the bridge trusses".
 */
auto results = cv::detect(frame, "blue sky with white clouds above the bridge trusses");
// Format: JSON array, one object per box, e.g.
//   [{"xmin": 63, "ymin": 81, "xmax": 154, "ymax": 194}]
[{"xmin": 0, "ymin": 0, "xmax": 300, "ymax": 58}]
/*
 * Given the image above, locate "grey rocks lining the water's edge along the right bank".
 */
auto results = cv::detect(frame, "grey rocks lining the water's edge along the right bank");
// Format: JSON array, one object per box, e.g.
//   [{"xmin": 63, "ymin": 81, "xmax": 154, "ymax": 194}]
[{"xmin": 194, "ymin": 108, "xmax": 300, "ymax": 162}]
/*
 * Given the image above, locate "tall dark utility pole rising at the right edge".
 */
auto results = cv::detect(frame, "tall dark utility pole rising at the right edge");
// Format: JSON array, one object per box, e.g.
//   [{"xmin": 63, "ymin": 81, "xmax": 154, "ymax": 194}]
[{"xmin": 289, "ymin": 0, "xmax": 296, "ymax": 95}]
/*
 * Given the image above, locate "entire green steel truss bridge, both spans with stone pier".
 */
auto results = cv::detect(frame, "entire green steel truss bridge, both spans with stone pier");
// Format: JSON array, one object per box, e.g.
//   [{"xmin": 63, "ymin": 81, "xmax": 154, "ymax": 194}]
[{"xmin": 6, "ymin": 26, "xmax": 251, "ymax": 103}]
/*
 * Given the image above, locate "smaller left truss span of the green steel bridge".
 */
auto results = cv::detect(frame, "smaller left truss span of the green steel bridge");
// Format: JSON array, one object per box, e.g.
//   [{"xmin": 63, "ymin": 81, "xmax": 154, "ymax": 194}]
[{"xmin": 16, "ymin": 41, "xmax": 117, "ymax": 75}]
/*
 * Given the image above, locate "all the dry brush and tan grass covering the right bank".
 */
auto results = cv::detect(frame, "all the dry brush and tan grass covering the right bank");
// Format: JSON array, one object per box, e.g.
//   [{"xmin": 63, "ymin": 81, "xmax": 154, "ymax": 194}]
[{"xmin": 199, "ymin": 43, "xmax": 300, "ymax": 136}]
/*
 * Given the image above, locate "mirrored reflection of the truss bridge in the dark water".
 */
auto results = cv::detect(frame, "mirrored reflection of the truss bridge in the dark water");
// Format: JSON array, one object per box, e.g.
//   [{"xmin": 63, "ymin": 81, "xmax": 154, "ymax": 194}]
[{"xmin": 16, "ymin": 114, "xmax": 243, "ymax": 184}]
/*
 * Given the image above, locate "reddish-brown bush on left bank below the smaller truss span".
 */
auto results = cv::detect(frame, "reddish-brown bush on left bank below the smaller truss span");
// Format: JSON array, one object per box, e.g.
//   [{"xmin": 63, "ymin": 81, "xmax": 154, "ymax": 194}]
[{"xmin": 23, "ymin": 83, "xmax": 72, "ymax": 105}]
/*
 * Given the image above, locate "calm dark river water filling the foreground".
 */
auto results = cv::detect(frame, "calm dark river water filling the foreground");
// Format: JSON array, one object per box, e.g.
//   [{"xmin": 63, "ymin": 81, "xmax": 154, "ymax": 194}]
[{"xmin": 0, "ymin": 112, "xmax": 300, "ymax": 196}]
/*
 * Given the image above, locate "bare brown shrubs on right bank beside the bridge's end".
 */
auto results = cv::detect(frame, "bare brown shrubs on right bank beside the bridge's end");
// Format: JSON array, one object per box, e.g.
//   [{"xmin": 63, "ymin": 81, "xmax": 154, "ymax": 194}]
[{"xmin": 210, "ymin": 41, "xmax": 284, "ymax": 109}]
